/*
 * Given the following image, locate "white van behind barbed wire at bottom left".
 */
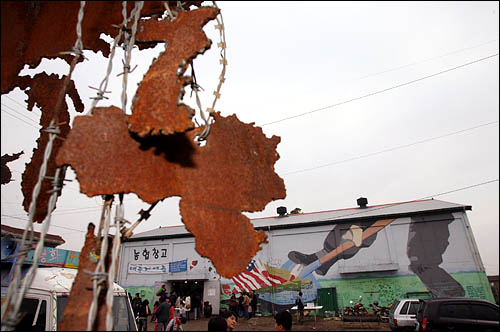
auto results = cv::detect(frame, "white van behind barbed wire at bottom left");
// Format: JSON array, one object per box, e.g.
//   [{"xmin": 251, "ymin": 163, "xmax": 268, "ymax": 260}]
[{"xmin": 2, "ymin": 267, "xmax": 137, "ymax": 331}]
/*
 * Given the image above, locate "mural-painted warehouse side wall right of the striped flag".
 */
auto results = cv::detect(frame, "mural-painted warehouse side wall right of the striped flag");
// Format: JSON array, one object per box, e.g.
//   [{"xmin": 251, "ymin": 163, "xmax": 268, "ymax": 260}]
[{"xmin": 221, "ymin": 213, "xmax": 494, "ymax": 313}]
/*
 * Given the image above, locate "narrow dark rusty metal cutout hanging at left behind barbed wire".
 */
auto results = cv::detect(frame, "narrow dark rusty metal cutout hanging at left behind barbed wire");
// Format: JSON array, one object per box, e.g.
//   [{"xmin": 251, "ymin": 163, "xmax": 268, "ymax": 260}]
[{"xmin": 19, "ymin": 73, "xmax": 83, "ymax": 222}]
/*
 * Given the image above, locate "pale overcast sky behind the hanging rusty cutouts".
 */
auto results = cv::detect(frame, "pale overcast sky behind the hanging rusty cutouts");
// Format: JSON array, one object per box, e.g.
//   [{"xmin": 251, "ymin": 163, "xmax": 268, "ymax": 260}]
[{"xmin": 1, "ymin": 1, "xmax": 499, "ymax": 275}]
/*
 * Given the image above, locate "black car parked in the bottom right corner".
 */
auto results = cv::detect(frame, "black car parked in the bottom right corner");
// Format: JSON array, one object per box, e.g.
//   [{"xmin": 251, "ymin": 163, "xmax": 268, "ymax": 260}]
[{"xmin": 417, "ymin": 298, "xmax": 499, "ymax": 331}]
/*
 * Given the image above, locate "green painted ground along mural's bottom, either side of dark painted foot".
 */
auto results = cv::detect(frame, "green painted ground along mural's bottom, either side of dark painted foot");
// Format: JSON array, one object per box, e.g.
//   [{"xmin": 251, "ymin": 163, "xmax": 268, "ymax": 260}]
[{"xmin": 319, "ymin": 272, "xmax": 495, "ymax": 308}]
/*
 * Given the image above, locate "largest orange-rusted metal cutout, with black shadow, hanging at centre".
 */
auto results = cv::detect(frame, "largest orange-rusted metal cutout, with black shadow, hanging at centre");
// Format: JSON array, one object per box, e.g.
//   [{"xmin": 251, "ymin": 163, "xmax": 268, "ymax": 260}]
[{"xmin": 56, "ymin": 107, "xmax": 285, "ymax": 276}]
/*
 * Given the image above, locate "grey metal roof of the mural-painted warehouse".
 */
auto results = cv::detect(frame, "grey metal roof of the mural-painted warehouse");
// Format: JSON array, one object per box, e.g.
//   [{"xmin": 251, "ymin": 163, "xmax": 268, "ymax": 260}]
[{"xmin": 130, "ymin": 199, "xmax": 472, "ymax": 241}]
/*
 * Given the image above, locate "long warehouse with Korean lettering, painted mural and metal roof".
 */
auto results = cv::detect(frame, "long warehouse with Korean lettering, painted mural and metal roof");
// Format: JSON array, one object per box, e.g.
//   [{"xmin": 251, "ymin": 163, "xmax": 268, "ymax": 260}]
[{"xmin": 118, "ymin": 198, "xmax": 495, "ymax": 315}]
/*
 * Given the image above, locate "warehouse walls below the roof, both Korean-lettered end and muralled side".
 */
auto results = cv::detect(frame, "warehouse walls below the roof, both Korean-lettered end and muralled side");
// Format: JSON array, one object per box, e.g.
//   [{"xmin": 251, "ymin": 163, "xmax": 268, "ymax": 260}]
[{"xmin": 118, "ymin": 212, "xmax": 494, "ymax": 314}]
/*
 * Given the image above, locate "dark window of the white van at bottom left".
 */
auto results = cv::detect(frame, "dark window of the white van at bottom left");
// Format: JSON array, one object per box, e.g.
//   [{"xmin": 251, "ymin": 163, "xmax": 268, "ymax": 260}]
[{"xmin": 14, "ymin": 298, "xmax": 47, "ymax": 331}]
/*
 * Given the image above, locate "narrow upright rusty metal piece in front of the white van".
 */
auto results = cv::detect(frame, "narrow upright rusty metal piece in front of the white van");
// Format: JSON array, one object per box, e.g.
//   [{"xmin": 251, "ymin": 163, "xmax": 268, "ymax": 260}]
[{"xmin": 58, "ymin": 223, "xmax": 113, "ymax": 331}]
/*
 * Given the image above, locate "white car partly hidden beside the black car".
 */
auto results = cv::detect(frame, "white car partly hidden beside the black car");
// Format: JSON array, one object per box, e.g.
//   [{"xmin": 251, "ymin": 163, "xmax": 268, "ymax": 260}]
[{"xmin": 389, "ymin": 299, "xmax": 420, "ymax": 331}]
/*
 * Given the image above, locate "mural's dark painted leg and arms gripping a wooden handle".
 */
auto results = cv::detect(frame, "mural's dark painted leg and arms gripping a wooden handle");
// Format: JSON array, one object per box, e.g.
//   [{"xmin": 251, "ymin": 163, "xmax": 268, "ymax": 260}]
[{"xmin": 288, "ymin": 213, "xmax": 465, "ymax": 296}]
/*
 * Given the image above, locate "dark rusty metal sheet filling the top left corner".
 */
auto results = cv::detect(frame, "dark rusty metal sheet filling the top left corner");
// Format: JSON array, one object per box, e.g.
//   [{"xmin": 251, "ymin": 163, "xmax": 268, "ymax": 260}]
[{"xmin": 1, "ymin": 1, "xmax": 165, "ymax": 93}]
